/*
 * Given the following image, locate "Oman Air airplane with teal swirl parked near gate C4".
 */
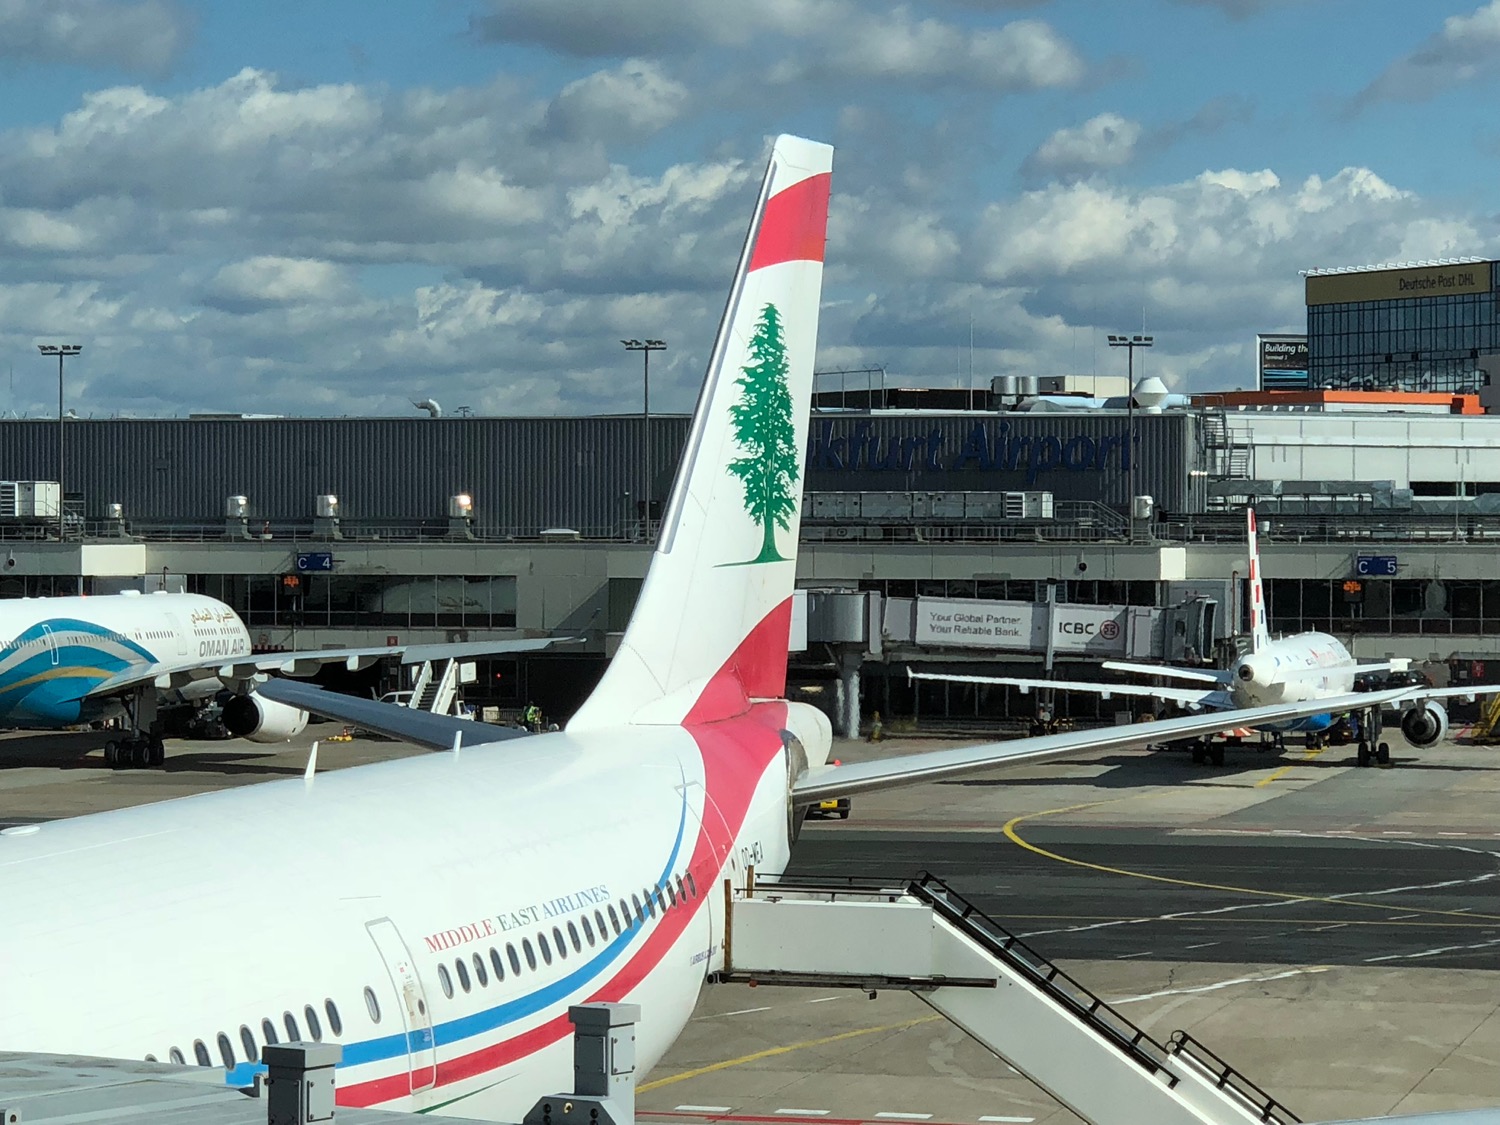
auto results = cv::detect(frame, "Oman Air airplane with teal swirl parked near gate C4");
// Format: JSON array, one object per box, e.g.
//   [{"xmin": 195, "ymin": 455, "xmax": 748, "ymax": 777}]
[{"xmin": 0, "ymin": 594, "xmax": 557, "ymax": 767}]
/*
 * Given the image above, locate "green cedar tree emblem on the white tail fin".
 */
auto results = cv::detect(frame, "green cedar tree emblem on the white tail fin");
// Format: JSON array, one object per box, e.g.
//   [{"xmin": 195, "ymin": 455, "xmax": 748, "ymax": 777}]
[{"xmin": 729, "ymin": 305, "xmax": 800, "ymax": 566}]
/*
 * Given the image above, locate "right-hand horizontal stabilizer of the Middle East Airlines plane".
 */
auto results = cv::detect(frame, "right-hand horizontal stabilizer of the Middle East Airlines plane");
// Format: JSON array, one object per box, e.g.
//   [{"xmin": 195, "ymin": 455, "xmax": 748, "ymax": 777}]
[{"xmin": 792, "ymin": 689, "xmax": 1412, "ymax": 804}]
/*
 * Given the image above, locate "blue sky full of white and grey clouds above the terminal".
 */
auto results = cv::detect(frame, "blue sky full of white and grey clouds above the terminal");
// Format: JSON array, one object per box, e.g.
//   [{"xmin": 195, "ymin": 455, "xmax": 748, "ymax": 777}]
[{"xmin": 0, "ymin": 0, "xmax": 1500, "ymax": 416}]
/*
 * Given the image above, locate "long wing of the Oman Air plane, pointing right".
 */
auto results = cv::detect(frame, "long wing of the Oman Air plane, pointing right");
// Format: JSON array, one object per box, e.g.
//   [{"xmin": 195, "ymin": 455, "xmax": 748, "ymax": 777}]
[{"xmin": 78, "ymin": 638, "xmax": 581, "ymax": 699}]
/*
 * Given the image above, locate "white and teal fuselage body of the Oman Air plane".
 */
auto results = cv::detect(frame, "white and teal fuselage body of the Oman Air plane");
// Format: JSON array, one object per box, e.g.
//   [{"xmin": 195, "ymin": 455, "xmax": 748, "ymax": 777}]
[{"xmin": 0, "ymin": 594, "xmax": 251, "ymax": 728}]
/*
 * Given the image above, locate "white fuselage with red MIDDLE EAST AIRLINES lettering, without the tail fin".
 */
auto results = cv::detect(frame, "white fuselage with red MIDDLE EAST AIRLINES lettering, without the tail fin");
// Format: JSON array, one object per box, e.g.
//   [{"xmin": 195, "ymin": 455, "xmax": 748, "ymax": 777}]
[{"xmin": 0, "ymin": 704, "xmax": 789, "ymax": 1121}]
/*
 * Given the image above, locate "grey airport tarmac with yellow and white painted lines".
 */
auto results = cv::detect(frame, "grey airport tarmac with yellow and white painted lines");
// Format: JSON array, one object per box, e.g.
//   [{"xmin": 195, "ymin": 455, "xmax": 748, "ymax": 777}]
[{"xmin": 0, "ymin": 726, "xmax": 1500, "ymax": 1125}]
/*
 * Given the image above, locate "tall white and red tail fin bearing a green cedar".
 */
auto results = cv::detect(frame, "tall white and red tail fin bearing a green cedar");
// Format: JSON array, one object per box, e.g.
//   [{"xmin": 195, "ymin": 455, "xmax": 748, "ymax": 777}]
[{"xmin": 569, "ymin": 137, "xmax": 833, "ymax": 731}]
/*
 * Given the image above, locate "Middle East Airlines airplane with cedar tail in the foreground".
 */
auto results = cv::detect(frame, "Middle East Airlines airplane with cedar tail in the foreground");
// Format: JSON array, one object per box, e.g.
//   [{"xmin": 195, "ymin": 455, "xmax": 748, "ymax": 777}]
[{"xmin": 0, "ymin": 137, "xmax": 1404, "ymax": 1121}]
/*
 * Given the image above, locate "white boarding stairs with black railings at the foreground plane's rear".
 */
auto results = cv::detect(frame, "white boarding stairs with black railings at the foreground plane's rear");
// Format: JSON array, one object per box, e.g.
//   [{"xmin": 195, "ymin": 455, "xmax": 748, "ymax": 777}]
[{"xmin": 716, "ymin": 873, "xmax": 1301, "ymax": 1125}]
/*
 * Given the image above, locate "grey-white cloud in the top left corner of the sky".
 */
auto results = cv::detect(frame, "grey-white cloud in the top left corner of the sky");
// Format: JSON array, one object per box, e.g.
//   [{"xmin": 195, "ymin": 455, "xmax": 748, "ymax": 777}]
[{"xmin": 0, "ymin": 0, "xmax": 189, "ymax": 74}]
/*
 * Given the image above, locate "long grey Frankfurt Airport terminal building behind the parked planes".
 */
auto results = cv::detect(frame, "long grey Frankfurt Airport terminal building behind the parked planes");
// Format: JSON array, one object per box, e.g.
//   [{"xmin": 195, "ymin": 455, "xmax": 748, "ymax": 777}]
[{"xmin": 0, "ymin": 384, "xmax": 1500, "ymax": 729}]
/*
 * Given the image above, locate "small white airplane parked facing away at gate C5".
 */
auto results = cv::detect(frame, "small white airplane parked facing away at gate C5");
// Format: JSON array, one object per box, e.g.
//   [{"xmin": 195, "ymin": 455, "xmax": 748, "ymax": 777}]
[{"xmin": 909, "ymin": 509, "xmax": 1476, "ymax": 765}]
